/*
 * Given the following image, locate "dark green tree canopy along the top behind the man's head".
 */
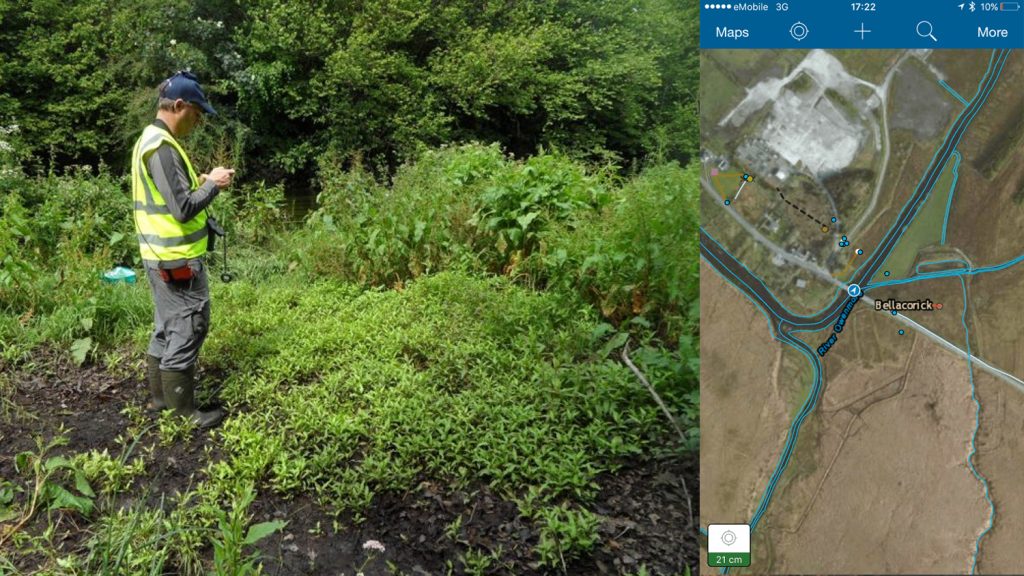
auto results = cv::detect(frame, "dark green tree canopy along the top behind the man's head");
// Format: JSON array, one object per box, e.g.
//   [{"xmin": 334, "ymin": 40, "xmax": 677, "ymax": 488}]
[{"xmin": 0, "ymin": 0, "xmax": 698, "ymax": 179}]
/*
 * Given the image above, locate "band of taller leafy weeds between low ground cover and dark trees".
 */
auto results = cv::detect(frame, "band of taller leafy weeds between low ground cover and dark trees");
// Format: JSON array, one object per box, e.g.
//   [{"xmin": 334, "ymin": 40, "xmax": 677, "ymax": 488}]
[{"xmin": 289, "ymin": 145, "xmax": 699, "ymax": 346}]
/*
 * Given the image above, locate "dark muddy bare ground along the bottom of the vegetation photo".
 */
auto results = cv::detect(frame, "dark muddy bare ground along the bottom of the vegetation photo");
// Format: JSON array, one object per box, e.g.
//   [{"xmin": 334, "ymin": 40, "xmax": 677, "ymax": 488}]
[{"xmin": 0, "ymin": 354, "xmax": 699, "ymax": 576}]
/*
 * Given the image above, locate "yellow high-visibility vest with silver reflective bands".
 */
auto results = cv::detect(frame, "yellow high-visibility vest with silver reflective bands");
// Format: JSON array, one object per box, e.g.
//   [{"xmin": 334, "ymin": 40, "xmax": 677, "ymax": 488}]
[{"xmin": 131, "ymin": 124, "xmax": 207, "ymax": 265}]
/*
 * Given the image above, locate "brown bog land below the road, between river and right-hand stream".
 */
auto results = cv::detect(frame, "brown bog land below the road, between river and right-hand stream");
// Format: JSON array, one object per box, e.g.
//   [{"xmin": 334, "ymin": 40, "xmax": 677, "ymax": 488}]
[{"xmin": 761, "ymin": 311, "xmax": 988, "ymax": 574}]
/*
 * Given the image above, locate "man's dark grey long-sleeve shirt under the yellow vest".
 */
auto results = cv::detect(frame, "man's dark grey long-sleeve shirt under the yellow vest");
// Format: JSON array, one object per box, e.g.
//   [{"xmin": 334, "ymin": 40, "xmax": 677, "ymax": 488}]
[{"xmin": 145, "ymin": 120, "xmax": 220, "ymax": 222}]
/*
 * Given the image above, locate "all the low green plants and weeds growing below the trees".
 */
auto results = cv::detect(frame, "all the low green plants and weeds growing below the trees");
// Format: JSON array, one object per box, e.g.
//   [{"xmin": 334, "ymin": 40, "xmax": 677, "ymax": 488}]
[{"xmin": 0, "ymin": 145, "xmax": 699, "ymax": 574}]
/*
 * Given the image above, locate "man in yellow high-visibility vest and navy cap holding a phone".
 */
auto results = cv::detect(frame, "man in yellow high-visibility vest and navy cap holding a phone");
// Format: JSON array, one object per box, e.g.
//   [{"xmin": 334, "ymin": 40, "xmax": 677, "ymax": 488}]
[{"xmin": 131, "ymin": 72, "xmax": 234, "ymax": 427}]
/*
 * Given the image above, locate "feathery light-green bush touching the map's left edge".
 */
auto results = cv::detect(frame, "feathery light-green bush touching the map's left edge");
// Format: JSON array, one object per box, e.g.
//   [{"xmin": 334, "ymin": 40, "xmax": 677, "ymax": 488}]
[{"xmin": 524, "ymin": 158, "xmax": 699, "ymax": 341}]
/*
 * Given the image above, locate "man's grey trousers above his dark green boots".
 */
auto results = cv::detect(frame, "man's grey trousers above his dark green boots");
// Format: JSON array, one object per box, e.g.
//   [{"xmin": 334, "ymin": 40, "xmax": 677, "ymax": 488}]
[{"xmin": 145, "ymin": 259, "xmax": 210, "ymax": 370}]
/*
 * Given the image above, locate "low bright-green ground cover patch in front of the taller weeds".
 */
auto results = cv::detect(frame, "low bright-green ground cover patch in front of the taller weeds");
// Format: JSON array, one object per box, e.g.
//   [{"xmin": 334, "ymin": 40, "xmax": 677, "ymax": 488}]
[{"xmin": 201, "ymin": 273, "xmax": 682, "ymax": 509}]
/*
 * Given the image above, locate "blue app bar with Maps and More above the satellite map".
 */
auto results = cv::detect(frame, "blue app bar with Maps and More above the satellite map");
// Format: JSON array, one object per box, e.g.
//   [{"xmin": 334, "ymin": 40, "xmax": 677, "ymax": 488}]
[{"xmin": 700, "ymin": 0, "xmax": 1024, "ymax": 48}]
